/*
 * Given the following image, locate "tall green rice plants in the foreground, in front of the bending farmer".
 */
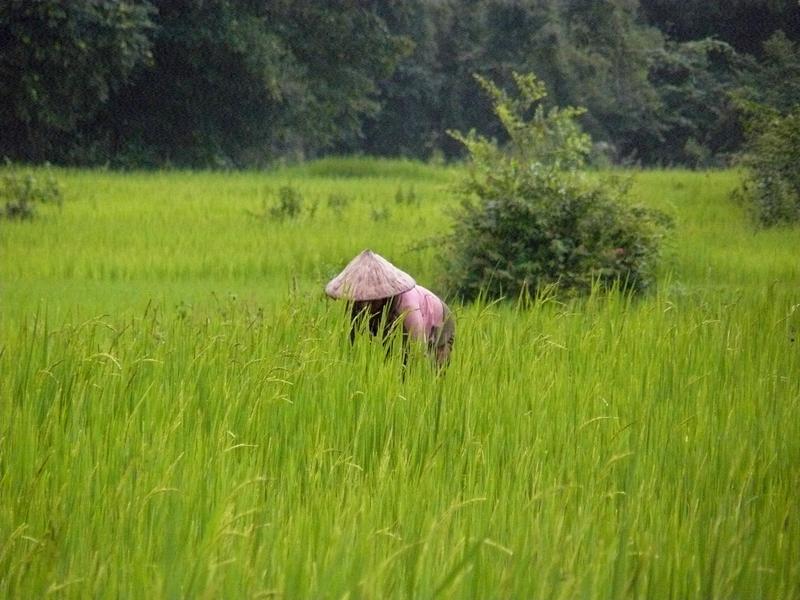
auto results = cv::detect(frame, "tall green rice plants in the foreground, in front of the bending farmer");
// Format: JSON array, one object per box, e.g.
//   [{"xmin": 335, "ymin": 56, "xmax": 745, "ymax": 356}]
[{"xmin": 0, "ymin": 293, "xmax": 800, "ymax": 598}]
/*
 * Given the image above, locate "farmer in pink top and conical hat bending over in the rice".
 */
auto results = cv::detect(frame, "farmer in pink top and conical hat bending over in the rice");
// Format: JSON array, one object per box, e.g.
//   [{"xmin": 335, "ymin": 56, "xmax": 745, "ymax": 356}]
[{"xmin": 325, "ymin": 250, "xmax": 456, "ymax": 367}]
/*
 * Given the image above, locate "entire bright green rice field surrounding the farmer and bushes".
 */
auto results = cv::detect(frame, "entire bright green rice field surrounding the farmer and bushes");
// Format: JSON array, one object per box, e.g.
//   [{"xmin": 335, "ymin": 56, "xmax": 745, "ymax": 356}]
[{"xmin": 0, "ymin": 159, "xmax": 800, "ymax": 599}]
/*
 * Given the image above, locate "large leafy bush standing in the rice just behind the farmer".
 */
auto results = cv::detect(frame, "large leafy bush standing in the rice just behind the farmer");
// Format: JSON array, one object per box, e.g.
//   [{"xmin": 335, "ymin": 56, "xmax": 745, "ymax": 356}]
[{"xmin": 445, "ymin": 74, "xmax": 668, "ymax": 299}]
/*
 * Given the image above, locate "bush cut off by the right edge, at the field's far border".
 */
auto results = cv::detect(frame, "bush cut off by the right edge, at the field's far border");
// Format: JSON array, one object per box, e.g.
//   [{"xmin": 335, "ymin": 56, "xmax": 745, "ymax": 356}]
[{"xmin": 735, "ymin": 103, "xmax": 800, "ymax": 227}]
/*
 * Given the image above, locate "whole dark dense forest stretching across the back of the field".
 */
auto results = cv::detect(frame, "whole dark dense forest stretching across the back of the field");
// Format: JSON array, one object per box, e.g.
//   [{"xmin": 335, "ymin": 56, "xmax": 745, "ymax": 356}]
[{"xmin": 0, "ymin": 0, "xmax": 800, "ymax": 168}]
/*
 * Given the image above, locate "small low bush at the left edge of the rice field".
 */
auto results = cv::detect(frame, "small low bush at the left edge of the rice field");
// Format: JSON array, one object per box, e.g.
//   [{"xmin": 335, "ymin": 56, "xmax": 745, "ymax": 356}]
[{"xmin": 0, "ymin": 163, "xmax": 64, "ymax": 220}]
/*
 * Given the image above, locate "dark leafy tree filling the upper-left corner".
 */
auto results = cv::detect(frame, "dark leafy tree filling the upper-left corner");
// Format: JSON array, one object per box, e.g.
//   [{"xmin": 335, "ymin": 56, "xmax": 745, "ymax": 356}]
[{"xmin": 0, "ymin": 0, "xmax": 153, "ymax": 161}]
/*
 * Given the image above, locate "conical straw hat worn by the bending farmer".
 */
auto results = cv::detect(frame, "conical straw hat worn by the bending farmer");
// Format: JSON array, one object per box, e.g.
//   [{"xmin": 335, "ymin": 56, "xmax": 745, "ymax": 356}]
[{"xmin": 325, "ymin": 250, "xmax": 416, "ymax": 300}]
